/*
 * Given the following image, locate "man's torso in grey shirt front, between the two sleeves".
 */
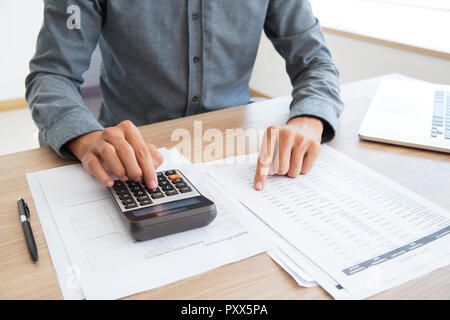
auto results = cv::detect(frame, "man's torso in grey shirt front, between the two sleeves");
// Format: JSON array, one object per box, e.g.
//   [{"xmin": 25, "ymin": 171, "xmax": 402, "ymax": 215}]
[{"xmin": 99, "ymin": 0, "xmax": 269, "ymax": 125}]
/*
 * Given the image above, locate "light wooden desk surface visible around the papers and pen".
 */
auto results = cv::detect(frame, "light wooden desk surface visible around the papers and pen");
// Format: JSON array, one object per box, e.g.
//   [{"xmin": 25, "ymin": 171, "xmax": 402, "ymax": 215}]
[{"xmin": 0, "ymin": 78, "xmax": 450, "ymax": 299}]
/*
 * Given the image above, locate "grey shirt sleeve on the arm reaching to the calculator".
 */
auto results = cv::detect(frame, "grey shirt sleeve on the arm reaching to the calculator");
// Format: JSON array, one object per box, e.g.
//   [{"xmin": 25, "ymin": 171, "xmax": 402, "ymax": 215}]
[{"xmin": 25, "ymin": 0, "xmax": 103, "ymax": 159}]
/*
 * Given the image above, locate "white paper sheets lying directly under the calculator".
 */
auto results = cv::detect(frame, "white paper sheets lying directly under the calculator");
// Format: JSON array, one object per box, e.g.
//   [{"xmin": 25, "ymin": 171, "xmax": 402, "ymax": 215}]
[{"xmin": 28, "ymin": 149, "xmax": 270, "ymax": 299}]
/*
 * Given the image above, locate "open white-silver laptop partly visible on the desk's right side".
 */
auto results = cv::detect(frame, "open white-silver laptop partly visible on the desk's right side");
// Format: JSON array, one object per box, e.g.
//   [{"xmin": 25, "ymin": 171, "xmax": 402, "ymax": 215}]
[{"xmin": 359, "ymin": 79, "xmax": 450, "ymax": 153}]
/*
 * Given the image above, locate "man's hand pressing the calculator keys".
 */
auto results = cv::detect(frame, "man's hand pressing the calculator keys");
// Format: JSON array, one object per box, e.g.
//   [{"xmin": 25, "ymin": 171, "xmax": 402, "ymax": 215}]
[{"xmin": 67, "ymin": 120, "xmax": 163, "ymax": 189}]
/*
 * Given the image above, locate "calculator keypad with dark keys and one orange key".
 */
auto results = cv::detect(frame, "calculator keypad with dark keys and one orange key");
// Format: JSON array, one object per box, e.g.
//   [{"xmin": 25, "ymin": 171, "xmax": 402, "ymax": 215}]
[{"xmin": 109, "ymin": 170, "xmax": 200, "ymax": 211}]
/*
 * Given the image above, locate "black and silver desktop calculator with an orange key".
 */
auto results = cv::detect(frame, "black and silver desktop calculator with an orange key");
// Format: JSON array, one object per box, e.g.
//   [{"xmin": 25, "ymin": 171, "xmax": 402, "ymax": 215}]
[{"xmin": 108, "ymin": 169, "xmax": 217, "ymax": 241}]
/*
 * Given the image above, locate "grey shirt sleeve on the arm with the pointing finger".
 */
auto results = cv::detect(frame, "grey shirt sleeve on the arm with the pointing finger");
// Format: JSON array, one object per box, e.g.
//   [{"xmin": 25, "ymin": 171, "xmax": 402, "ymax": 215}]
[{"xmin": 264, "ymin": 0, "xmax": 344, "ymax": 142}]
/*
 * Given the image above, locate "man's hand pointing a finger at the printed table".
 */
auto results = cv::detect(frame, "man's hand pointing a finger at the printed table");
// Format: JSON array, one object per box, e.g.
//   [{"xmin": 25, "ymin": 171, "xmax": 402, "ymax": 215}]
[{"xmin": 254, "ymin": 116, "xmax": 323, "ymax": 190}]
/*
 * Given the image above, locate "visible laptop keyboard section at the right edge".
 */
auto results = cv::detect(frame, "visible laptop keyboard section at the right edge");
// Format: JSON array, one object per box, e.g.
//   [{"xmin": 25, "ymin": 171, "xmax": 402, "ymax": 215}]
[{"xmin": 431, "ymin": 91, "xmax": 450, "ymax": 139}]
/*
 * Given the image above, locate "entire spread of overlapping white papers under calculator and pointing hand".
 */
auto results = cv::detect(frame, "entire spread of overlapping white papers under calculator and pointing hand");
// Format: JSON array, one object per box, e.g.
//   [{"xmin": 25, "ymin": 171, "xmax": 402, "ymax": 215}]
[{"xmin": 27, "ymin": 141, "xmax": 450, "ymax": 299}]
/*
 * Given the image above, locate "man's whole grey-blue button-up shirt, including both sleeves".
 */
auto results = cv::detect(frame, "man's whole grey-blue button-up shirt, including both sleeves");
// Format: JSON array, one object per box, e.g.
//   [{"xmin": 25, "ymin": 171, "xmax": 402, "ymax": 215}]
[{"xmin": 26, "ymin": 0, "xmax": 343, "ymax": 157}]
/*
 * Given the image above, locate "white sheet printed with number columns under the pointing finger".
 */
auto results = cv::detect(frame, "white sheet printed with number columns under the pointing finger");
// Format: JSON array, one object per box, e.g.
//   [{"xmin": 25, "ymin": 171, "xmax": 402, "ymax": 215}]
[{"xmin": 210, "ymin": 146, "xmax": 450, "ymax": 298}]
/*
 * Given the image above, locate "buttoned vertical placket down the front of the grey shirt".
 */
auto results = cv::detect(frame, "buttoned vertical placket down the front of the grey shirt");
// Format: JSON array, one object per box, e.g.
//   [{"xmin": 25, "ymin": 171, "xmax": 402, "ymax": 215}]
[{"xmin": 186, "ymin": 0, "xmax": 203, "ymax": 115}]
